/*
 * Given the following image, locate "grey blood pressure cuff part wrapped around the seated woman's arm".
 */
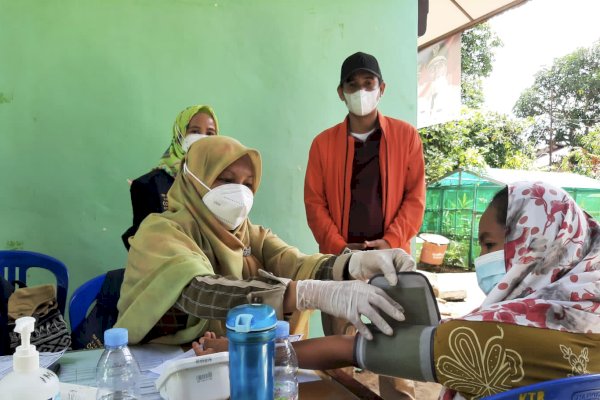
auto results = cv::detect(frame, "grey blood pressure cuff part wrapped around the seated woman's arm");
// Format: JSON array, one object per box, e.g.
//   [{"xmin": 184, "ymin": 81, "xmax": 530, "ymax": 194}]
[{"xmin": 354, "ymin": 325, "xmax": 437, "ymax": 382}]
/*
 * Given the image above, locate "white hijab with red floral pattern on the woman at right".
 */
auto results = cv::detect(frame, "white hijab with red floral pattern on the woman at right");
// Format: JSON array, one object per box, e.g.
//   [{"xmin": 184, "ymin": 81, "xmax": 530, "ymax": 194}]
[{"xmin": 461, "ymin": 182, "xmax": 600, "ymax": 333}]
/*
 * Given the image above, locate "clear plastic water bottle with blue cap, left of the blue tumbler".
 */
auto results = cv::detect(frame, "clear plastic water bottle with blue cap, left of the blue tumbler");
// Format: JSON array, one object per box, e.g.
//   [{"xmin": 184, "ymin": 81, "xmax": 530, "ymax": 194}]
[{"xmin": 96, "ymin": 328, "xmax": 141, "ymax": 400}]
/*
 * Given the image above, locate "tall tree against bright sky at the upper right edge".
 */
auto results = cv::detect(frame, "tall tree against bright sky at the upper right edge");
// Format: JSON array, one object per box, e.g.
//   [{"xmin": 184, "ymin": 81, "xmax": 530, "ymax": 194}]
[{"xmin": 513, "ymin": 42, "xmax": 600, "ymax": 150}]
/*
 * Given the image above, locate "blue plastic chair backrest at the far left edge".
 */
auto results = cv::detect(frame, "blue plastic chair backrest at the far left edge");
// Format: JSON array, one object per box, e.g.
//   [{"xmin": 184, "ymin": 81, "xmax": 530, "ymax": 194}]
[{"xmin": 0, "ymin": 250, "xmax": 69, "ymax": 315}]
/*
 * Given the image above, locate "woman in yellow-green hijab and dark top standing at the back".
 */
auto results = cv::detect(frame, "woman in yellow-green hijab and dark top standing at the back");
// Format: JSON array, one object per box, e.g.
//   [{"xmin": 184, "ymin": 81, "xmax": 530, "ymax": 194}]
[{"xmin": 121, "ymin": 105, "xmax": 219, "ymax": 250}]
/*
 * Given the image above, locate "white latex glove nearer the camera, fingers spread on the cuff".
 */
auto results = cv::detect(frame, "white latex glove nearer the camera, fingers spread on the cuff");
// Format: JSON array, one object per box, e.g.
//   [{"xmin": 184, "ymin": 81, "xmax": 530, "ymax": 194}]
[{"xmin": 296, "ymin": 280, "xmax": 404, "ymax": 340}]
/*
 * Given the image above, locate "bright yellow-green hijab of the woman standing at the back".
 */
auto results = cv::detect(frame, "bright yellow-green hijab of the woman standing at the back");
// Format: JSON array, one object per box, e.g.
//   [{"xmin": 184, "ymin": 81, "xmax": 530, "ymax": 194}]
[{"xmin": 156, "ymin": 104, "xmax": 219, "ymax": 176}]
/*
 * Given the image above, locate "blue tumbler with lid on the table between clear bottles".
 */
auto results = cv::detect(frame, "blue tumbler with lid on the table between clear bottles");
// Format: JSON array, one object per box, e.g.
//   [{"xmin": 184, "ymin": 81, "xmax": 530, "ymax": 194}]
[{"xmin": 226, "ymin": 304, "xmax": 277, "ymax": 400}]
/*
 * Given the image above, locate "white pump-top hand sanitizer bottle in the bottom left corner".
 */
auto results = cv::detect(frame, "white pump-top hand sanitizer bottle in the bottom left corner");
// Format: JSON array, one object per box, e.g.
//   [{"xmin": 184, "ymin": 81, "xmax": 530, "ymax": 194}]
[{"xmin": 0, "ymin": 317, "xmax": 60, "ymax": 400}]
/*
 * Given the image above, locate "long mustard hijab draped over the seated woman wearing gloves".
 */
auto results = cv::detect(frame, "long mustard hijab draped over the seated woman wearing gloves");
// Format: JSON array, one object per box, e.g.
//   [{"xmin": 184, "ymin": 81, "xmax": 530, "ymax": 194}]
[{"xmin": 115, "ymin": 136, "xmax": 329, "ymax": 344}]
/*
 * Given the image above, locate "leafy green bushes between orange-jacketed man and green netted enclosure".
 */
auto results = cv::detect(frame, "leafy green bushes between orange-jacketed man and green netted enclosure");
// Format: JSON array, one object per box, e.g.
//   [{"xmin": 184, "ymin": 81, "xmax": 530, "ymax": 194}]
[{"xmin": 420, "ymin": 110, "xmax": 534, "ymax": 182}]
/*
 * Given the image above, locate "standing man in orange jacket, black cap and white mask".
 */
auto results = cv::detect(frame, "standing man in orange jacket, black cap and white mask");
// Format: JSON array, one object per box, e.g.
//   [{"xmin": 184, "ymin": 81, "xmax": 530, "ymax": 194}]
[{"xmin": 304, "ymin": 52, "xmax": 425, "ymax": 254}]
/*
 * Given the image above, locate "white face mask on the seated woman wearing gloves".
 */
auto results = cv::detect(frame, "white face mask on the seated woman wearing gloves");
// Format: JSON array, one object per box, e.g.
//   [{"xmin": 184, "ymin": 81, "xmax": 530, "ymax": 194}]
[{"xmin": 183, "ymin": 164, "xmax": 254, "ymax": 231}]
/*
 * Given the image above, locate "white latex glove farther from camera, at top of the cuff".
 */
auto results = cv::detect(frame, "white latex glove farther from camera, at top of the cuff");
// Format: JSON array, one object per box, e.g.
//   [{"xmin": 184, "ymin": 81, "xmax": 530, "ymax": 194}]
[{"xmin": 348, "ymin": 249, "xmax": 416, "ymax": 286}]
